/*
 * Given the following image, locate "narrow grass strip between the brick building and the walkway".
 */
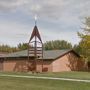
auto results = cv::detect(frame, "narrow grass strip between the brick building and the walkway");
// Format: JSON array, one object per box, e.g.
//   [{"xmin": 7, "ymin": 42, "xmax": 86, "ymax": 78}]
[{"xmin": 0, "ymin": 72, "xmax": 90, "ymax": 80}]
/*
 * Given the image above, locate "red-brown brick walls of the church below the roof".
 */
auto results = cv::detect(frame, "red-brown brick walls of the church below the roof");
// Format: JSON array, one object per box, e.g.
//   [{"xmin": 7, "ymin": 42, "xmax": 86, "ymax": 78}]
[{"xmin": 0, "ymin": 52, "xmax": 84, "ymax": 72}]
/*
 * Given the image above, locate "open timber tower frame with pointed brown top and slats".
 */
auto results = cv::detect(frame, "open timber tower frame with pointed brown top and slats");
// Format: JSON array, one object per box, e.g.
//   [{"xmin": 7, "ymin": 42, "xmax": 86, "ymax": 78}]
[{"xmin": 28, "ymin": 18, "xmax": 43, "ymax": 72}]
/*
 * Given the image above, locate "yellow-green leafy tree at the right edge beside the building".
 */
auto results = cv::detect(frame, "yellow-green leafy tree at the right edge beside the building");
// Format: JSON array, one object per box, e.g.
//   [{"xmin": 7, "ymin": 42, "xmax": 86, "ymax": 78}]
[{"xmin": 77, "ymin": 17, "xmax": 90, "ymax": 61}]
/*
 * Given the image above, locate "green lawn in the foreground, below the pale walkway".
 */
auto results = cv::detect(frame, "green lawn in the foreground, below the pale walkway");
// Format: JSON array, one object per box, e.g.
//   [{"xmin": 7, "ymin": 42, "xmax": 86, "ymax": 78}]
[{"xmin": 0, "ymin": 76, "xmax": 90, "ymax": 90}]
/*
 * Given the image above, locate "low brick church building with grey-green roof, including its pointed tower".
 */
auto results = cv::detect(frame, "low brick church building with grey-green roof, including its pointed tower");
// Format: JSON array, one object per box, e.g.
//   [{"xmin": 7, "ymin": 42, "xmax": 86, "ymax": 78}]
[{"xmin": 0, "ymin": 22, "xmax": 84, "ymax": 72}]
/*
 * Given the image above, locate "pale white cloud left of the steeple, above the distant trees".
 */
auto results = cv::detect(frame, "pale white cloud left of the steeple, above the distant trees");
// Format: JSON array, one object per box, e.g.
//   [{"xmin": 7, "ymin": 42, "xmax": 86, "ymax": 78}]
[{"xmin": 0, "ymin": 21, "xmax": 32, "ymax": 46}]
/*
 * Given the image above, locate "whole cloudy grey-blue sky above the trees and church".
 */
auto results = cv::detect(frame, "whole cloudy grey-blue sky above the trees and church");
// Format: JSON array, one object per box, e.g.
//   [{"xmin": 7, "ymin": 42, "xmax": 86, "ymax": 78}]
[{"xmin": 0, "ymin": 0, "xmax": 90, "ymax": 46}]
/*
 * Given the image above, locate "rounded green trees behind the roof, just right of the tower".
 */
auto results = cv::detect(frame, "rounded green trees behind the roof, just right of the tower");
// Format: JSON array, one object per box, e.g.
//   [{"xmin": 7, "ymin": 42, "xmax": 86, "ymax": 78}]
[{"xmin": 44, "ymin": 40, "xmax": 72, "ymax": 50}]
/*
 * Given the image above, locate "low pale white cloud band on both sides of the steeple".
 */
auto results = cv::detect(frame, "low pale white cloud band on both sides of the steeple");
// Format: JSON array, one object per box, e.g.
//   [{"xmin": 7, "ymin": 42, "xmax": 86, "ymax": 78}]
[{"xmin": 0, "ymin": 18, "xmax": 79, "ymax": 46}]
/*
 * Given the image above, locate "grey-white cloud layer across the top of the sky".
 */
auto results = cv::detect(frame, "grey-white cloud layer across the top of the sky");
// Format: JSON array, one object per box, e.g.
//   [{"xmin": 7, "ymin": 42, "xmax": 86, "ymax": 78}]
[{"xmin": 0, "ymin": 0, "xmax": 90, "ymax": 32}]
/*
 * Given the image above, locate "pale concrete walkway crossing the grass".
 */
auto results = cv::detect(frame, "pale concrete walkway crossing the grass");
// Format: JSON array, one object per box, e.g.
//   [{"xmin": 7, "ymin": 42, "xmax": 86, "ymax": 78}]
[{"xmin": 0, "ymin": 74, "xmax": 90, "ymax": 83}]
